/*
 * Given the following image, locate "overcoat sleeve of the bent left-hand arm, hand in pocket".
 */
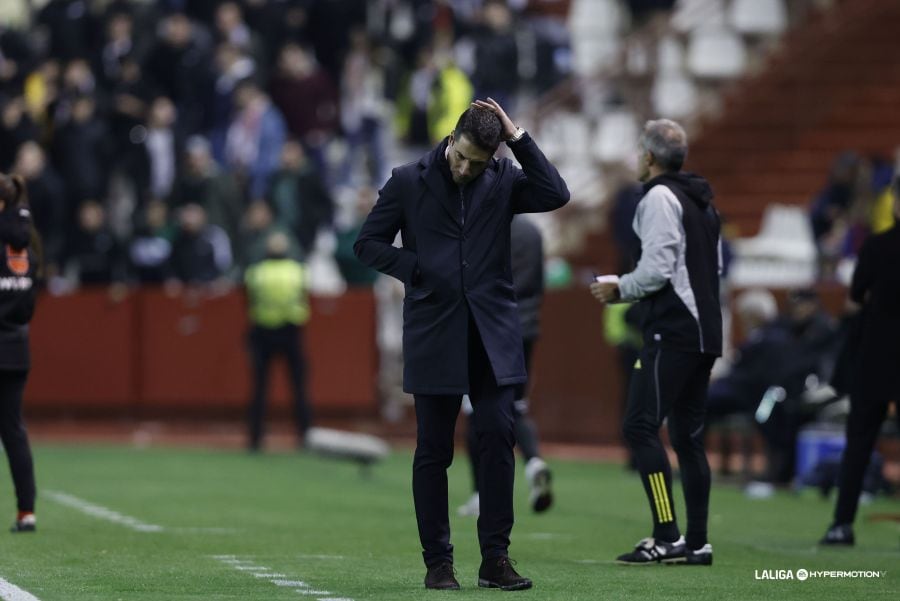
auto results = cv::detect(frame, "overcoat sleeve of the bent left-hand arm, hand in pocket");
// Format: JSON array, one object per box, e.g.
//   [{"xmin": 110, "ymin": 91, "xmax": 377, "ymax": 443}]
[{"xmin": 353, "ymin": 169, "xmax": 418, "ymax": 284}]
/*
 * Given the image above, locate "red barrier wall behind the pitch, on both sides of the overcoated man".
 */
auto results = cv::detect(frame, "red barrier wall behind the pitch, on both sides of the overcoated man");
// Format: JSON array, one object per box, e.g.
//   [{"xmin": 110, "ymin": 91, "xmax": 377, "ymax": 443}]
[{"xmin": 26, "ymin": 287, "xmax": 845, "ymax": 444}]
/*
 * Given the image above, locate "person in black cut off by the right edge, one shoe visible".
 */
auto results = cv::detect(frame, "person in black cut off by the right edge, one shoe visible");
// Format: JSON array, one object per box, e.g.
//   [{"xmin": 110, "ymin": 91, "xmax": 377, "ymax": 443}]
[{"xmin": 819, "ymin": 178, "xmax": 900, "ymax": 546}]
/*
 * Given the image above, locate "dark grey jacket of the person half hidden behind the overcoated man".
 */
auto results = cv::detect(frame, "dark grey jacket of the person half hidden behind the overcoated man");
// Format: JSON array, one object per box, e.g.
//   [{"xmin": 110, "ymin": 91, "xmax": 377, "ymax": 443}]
[{"xmin": 510, "ymin": 215, "xmax": 544, "ymax": 340}]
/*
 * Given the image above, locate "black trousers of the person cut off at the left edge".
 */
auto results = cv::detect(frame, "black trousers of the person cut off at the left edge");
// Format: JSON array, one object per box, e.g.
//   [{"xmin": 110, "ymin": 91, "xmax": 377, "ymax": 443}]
[{"xmin": 0, "ymin": 369, "xmax": 36, "ymax": 511}]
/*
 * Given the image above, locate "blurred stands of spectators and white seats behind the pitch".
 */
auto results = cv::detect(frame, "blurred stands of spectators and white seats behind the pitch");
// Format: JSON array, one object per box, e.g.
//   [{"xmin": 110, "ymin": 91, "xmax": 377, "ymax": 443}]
[{"xmin": 0, "ymin": 0, "xmax": 894, "ymax": 292}]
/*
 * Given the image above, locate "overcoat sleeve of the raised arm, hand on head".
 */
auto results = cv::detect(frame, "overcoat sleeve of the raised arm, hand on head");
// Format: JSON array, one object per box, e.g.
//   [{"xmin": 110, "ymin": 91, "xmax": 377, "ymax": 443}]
[{"xmin": 509, "ymin": 133, "xmax": 569, "ymax": 213}]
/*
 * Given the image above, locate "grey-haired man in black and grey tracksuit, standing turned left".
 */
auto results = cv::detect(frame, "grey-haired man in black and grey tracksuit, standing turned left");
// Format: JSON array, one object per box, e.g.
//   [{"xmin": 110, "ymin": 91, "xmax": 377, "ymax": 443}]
[{"xmin": 591, "ymin": 119, "xmax": 722, "ymax": 565}]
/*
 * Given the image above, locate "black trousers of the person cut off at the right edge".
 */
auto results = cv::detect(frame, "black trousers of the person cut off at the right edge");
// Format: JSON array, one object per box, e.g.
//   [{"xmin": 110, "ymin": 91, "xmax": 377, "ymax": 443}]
[{"xmin": 834, "ymin": 394, "xmax": 900, "ymax": 524}]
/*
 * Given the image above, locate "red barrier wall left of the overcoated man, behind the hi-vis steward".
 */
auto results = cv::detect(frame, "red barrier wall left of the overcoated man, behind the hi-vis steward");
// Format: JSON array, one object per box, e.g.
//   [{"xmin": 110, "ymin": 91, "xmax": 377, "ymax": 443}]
[{"xmin": 26, "ymin": 289, "xmax": 378, "ymax": 412}]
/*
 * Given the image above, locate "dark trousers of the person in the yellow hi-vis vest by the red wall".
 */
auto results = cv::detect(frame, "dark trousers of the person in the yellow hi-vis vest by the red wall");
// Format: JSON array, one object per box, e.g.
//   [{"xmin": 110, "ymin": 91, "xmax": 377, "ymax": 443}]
[{"xmin": 249, "ymin": 325, "xmax": 312, "ymax": 449}]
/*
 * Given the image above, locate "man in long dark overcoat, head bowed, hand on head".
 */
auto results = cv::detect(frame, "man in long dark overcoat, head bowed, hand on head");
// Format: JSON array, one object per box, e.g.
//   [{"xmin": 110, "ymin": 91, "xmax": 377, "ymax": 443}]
[{"xmin": 354, "ymin": 98, "xmax": 569, "ymax": 590}]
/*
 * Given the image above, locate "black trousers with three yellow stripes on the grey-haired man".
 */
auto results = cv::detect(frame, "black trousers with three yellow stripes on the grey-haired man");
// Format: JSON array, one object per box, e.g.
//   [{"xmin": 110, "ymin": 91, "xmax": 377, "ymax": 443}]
[{"xmin": 623, "ymin": 347, "xmax": 715, "ymax": 549}]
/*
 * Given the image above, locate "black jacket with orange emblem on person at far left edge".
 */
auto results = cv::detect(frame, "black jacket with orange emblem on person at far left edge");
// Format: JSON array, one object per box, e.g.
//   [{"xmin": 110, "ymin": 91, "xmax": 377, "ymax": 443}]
[{"xmin": 0, "ymin": 206, "xmax": 38, "ymax": 370}]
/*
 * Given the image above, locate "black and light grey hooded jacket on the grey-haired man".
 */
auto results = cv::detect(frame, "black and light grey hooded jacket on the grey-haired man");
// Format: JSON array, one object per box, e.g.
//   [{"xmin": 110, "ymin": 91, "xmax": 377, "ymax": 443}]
[{"xmin": 619, "ymin": 173, "xmax": 722, "ymax": 356}]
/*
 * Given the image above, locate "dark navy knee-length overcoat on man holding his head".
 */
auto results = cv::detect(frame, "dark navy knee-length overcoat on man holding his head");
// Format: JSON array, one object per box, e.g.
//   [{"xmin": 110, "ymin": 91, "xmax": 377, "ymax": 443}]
[{"xmin": 354, "ymin": 135, "xmax": 569, "ymax": 394}]
